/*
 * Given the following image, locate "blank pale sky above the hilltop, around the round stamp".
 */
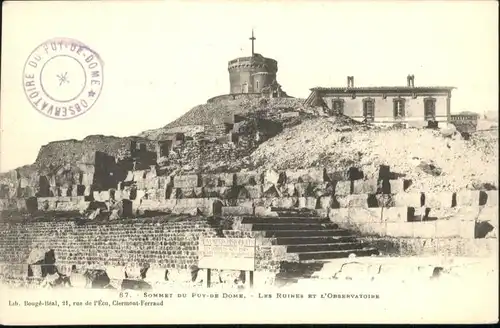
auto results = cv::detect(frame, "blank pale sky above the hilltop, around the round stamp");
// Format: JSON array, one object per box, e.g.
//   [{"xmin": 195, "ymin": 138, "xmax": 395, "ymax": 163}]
[{"xmin": 0, "ymin": 1, "xmax": 498, "ymax": 172}]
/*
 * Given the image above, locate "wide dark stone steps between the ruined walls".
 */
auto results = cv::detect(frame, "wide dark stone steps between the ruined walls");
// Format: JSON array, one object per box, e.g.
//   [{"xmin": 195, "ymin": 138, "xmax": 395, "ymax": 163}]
[{"xmin": 242, "ymin": 208, "xmax": 379, "ymax": 262}]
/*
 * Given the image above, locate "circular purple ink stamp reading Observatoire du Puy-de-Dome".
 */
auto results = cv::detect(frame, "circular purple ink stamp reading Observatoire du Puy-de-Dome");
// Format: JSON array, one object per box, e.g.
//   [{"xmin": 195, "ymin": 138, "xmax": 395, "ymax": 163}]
[{"xmin": 23, "ymin": 38, "xmax": 103, "ymax": 120}]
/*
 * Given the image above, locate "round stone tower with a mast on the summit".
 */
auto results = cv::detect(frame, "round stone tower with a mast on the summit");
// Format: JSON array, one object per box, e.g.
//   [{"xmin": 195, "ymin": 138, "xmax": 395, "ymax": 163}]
[{"xmin": 228, "ymin": 31, "xmax": 278, "ymax": 94}]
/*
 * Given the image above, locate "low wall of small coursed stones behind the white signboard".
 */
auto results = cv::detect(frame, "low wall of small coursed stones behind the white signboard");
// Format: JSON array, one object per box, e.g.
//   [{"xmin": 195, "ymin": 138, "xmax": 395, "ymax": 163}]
[{"xmin": 0, "ymin": 216, "xmax": 286, "ymax": 280}]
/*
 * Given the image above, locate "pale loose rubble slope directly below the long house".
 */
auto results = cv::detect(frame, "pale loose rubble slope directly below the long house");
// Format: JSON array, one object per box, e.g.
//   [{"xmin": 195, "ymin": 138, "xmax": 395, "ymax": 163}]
[{"xmin": 250, "ymin": 117, "xmax": 498, "ymax": 192}]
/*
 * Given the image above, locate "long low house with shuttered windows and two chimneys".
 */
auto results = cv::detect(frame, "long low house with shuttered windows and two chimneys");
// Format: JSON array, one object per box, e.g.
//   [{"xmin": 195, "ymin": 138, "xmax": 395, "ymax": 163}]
[{"xmin": 306, "ymin": 75, "xmax": 454, "ymax": 126}]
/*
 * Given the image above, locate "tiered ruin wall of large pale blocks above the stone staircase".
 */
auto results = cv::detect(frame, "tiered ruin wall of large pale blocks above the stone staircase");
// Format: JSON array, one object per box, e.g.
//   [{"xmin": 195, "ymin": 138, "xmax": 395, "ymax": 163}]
[{"xmin": 1, "ymin": 169, "xmax": 498, "ymax": 255}]
